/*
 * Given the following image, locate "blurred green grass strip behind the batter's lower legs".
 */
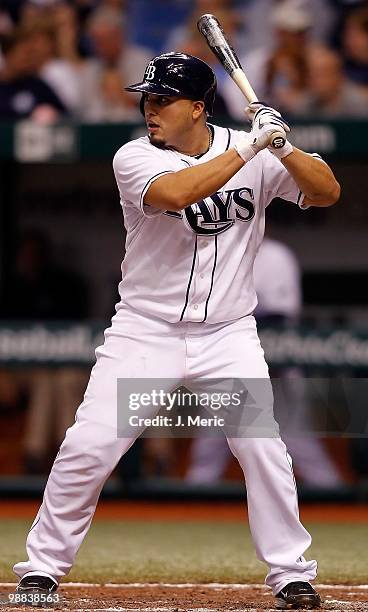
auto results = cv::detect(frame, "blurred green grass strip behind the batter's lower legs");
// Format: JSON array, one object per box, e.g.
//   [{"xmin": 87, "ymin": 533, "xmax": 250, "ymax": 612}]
[{"xmin": 0, "ymin": 520, "xmax": 368, "ymax": 584}]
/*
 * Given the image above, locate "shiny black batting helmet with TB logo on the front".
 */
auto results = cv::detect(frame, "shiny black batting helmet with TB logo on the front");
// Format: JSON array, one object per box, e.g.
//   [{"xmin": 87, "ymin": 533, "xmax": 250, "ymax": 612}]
[{"xmin": 125, "ymin": 53, "xmax": 217, "ymax": 116}]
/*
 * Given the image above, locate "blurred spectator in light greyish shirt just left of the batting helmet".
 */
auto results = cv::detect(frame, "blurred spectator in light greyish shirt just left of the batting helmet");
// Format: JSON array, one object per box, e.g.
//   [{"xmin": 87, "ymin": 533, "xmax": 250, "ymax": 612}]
[{"xmin": 81, "ymin": 7, "xmax": 152, "ymax": 121}]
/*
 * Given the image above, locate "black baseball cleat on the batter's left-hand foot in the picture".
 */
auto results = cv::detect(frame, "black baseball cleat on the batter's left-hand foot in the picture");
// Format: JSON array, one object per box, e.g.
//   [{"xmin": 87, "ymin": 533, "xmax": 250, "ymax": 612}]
[{"xmin": 14, "ymin": 574, "xmax": 59, "ymax": 608}]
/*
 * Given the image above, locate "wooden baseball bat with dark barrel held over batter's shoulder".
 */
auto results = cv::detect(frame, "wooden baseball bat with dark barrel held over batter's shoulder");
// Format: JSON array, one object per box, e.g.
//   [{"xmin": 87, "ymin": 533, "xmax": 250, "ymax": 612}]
[{"xmin": 197, "ymin": 14, "xmax": 286, "ymax": 149}]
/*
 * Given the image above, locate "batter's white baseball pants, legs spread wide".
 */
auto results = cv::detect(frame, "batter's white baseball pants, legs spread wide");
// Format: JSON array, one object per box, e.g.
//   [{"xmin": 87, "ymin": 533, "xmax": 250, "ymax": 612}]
[{"xmin": 14, "ymin": 306, "xmax": 317, "ymax": 594}]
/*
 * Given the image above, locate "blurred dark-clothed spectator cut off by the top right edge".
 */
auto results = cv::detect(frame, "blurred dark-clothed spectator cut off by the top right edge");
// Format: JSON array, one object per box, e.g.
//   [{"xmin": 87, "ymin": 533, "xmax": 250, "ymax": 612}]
[{"xmin": 342, "ymin": 4, "xmax": 368, "ymax": 96}]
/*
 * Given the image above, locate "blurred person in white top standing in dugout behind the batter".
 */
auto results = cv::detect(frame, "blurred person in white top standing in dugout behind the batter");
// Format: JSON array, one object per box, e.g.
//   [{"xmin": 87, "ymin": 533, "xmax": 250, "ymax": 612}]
[{"xmin": 254, "ymin": 236, "xmax": 343, "ymax": 488}]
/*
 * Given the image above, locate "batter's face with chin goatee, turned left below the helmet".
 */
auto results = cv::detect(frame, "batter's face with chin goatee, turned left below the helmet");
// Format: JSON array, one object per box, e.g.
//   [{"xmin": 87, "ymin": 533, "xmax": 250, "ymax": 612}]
[{"xmin": 144, "ymin": 94, "xmax": 201, "ymax": 148}]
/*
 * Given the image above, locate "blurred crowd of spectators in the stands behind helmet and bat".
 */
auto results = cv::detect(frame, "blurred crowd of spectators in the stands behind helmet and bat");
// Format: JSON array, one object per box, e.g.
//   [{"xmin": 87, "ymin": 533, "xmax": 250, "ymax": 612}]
[{"xmin": 0, "ymin": 0, "xmax": 368, "ymax": 122}]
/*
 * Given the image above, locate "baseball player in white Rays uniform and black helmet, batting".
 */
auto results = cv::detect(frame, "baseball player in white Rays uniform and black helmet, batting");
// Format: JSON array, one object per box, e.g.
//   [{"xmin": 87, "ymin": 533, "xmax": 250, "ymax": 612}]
[{"xmin": 14, "ymin": 53, "xmax": 340, "ymax": 608}]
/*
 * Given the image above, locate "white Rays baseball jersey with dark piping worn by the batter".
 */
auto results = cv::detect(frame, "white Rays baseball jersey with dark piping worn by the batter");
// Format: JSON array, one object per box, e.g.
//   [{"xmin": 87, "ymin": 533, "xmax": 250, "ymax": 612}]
[{"xmin": 113, "ymin": 126, "xmax": 303, "ymax": 323}]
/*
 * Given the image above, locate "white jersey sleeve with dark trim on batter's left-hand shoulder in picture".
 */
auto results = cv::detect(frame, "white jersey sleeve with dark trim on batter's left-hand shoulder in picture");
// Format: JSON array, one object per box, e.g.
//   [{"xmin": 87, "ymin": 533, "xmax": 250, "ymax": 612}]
[{"xmin": 113, "ymin": 139, "xmax": 176, "ymax": 217}]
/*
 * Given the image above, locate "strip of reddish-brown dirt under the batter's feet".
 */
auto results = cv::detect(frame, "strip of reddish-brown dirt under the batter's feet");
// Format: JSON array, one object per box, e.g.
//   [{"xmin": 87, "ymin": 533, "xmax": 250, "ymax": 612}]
[{"xmin": 0, "ymin": 585, "xmax": 368, "ymax": 612}]
